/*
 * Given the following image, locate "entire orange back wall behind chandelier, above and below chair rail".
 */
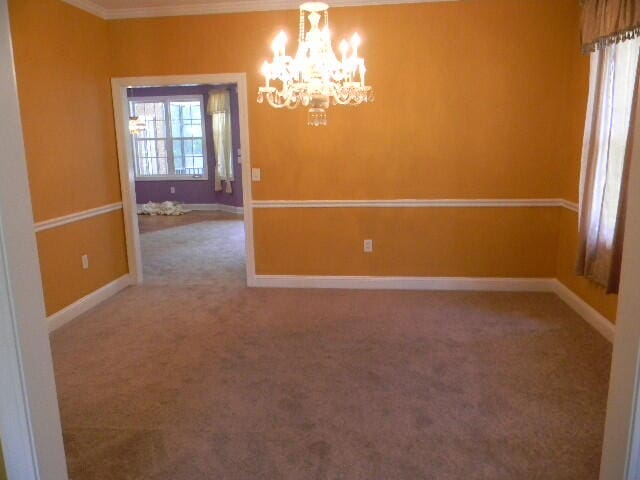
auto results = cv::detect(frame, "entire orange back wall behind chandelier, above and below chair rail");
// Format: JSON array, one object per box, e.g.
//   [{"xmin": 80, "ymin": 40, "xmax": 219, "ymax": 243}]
[{"xmin": 109, "ymin": 0, "xmax": 579, "ymax": 277}]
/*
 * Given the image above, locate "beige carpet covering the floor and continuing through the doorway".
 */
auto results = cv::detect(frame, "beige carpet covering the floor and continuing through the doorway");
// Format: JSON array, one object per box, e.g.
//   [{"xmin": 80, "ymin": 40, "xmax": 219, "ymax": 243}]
[{"xmin": 52, "ymin": 215, "xmax": 611, "ymax": 480}]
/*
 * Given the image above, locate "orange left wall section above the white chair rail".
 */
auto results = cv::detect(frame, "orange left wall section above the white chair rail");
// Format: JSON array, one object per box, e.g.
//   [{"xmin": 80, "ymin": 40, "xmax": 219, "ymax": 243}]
[{"xmin": 9, "ymin": 0, "xmax": 120, "ymax": 221}]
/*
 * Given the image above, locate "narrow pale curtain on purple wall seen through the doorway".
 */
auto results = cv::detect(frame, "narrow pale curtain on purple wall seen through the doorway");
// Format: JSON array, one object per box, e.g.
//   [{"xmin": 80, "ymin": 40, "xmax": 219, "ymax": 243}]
[{"xmin": 207, "ymin": 90, "xmax": 233, "ymax": 193}]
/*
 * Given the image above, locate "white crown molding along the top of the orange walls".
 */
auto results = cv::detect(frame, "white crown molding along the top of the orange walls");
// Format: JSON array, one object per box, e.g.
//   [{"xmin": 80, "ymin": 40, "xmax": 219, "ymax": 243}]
[{"xmin": 62, "ymin": 0, "xmax": 459, "ymax": 20}]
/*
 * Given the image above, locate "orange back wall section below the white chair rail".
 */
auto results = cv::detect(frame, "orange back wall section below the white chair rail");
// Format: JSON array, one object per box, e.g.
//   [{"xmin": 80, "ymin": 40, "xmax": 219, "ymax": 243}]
[{"xmin": 254, "ymin": 208, "xmax": 558, "ymax": 277}]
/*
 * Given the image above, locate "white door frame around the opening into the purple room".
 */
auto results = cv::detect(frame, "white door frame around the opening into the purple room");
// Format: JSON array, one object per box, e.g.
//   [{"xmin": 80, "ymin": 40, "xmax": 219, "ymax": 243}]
[{"xmin": 111, "ymin": 73, "xmax": 256, "ymax": 286}]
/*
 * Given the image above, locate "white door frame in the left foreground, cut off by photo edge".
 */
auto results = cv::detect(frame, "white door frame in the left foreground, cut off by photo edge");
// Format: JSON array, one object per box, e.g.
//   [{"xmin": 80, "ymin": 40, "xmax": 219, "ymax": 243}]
[{"xmin": 0, "ymin": 0, "xmax": 68, "ymax": 480}]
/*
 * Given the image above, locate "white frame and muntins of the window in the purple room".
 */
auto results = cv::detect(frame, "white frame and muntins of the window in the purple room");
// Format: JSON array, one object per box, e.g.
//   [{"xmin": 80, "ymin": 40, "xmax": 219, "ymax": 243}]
[{"xmin": 127, "ymin": 94, "xmax": 209, "ymax": 182}]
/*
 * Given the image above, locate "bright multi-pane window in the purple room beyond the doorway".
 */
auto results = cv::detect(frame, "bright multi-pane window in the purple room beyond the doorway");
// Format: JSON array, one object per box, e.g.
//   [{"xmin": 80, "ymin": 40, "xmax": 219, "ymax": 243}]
[{"xmin": 129, "ymin": 96, "xmax": 207, "ymax": 180}]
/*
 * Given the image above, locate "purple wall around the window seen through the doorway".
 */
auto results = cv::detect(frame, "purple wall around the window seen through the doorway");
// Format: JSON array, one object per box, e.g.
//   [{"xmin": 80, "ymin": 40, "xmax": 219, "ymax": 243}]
[{"xmin": 129, "ymin": 85, "xmax": 242, "ymax": 207}]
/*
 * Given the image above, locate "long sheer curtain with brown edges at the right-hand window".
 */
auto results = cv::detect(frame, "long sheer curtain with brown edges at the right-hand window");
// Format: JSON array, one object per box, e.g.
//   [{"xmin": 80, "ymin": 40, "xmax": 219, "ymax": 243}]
[{"xmin": 577, "ymin": 39, "xmax": 640, "ymax": 293}]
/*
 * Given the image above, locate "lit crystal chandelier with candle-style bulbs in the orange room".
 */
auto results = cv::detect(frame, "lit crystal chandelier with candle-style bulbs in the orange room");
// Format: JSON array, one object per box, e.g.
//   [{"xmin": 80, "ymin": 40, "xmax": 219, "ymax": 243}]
[{"xmin": 258, "ymin": 2, "xmax": 373, "ymax": 126}]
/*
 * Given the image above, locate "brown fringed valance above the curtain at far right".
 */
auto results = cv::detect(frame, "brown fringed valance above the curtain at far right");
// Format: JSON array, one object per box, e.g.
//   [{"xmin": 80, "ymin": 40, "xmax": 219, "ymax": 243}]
[{"xmin": 581, "ymin": 0, "xmax": 640, "ymax": 52}]
